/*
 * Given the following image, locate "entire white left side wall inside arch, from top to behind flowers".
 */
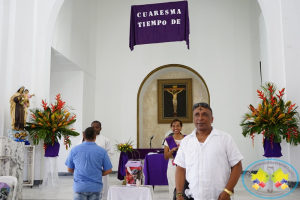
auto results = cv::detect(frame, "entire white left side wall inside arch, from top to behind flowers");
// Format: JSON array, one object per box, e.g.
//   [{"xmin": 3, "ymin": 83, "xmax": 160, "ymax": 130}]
[{"xmin": 50, "ymin": 0, "xmax": 97, "ymax": 172}]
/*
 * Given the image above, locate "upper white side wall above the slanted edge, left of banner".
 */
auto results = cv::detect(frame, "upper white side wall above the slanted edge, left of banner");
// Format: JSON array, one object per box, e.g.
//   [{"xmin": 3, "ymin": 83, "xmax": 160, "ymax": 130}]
[{"xmin": 52, "ymin": 0, "xmax": 97, "ymax": 77}]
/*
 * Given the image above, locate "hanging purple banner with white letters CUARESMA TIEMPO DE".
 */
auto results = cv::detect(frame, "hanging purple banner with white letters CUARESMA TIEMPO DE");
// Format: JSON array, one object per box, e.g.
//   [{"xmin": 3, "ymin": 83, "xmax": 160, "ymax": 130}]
[{"xmin": 129, "ymin": 1, "xmax": 190, "ymax": 51}]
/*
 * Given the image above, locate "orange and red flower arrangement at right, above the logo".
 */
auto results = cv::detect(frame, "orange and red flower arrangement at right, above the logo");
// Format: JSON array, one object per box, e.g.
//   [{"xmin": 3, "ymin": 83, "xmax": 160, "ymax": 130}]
[{"xmin": 240, "ymin": 83, "xmax": 300, "ymax": 146}]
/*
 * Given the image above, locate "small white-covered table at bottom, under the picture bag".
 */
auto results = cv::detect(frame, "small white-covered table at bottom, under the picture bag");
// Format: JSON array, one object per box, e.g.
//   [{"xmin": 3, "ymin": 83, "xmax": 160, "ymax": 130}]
[{"xmin": 107, "ymin": 185, "xmax": 154, "ymax": 200}]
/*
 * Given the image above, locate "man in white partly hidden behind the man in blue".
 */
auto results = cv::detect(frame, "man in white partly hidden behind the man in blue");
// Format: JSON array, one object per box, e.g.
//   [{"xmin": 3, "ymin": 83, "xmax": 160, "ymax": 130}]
[{"xmin": 80, "ymin": 121, "xmax": 114, "ymax": 198}]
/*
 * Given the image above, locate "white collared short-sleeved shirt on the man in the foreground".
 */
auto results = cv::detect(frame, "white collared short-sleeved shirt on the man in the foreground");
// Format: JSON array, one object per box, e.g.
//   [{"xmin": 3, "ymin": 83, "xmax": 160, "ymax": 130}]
[{"xmin": 175, "ymin": 128, "xmax": 244, "ymax": 200}]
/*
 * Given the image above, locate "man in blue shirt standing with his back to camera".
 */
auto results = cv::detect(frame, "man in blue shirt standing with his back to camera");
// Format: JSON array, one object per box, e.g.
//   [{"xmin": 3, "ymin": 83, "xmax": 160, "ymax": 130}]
[{"xmin": 65, "ymin": 127, "xmax": 112, "ymax": 200}]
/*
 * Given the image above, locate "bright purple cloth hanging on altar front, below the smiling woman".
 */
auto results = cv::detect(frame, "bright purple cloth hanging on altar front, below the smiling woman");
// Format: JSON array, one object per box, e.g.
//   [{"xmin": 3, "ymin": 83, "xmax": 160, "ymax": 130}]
[{"xmin": 143, "ymin": 154, "xmax": 169, "ymax": 185}]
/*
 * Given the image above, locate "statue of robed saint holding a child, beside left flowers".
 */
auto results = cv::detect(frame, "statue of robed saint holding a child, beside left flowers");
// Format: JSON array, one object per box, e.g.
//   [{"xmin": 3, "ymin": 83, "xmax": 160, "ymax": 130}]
[{"xmin": 9, "ymin": 86, "xmax": 25, "ymax": 131}]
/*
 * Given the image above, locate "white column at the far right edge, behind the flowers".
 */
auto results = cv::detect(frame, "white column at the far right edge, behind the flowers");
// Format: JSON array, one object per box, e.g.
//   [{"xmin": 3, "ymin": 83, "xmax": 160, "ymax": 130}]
[{"xmin": 281, "ymin": 0, "xmax": 300, "ymax": 181}]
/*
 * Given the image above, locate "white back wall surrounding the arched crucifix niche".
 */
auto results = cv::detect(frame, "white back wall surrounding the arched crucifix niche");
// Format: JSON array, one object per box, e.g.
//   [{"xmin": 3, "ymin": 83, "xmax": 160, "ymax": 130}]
[{"xmin": 95, "ymin": 0, "xmax": 260, "ymax": 170}]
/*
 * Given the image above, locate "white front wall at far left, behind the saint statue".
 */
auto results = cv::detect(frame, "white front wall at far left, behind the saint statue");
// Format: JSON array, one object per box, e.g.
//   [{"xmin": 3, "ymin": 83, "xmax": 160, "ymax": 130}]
[{"xmin": 0, "ymin": 0, "xmax": 63, "ymax": 180}]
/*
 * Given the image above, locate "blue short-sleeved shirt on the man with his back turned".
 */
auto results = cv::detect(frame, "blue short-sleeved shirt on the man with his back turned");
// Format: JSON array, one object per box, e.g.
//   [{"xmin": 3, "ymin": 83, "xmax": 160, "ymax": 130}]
[{"xmin": 65, "ymin": 141, "xmax": 112, "ymax": 192}]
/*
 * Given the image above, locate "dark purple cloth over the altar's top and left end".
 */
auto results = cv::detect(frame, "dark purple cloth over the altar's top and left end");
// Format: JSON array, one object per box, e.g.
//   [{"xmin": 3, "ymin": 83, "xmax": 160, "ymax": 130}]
[{"xmin": 118, "ymin": 149, "xmax": 164, "ymax": 181}]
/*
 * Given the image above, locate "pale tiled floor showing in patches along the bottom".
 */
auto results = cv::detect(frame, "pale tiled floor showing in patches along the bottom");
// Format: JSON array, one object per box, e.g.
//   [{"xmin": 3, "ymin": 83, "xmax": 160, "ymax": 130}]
[{"xmin": 23, "ymin": 174, "xmax": 300, "ymax": 200}]
